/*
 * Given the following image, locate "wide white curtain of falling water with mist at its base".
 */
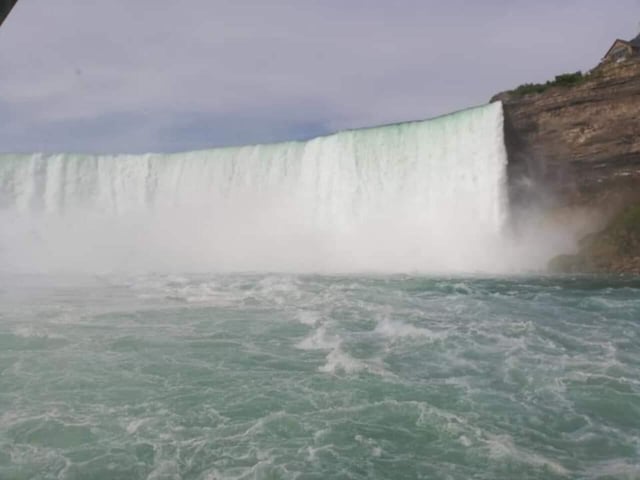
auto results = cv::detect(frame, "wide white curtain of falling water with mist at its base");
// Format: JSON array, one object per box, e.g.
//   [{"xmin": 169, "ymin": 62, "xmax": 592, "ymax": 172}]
[{"xmin": 0, "ymin": 103, "xmax": 507, "ymax": 272}]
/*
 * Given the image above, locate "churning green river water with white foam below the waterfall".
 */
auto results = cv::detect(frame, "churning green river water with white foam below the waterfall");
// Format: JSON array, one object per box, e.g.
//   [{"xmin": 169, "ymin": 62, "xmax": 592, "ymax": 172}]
[{"xmin": 0, "ymin": 275, "xmax": 640, "ymax": 480}]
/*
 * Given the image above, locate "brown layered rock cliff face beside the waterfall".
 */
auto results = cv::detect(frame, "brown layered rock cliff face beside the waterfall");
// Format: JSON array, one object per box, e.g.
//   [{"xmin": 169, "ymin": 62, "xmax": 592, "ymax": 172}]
[{"xmin": 492, "ymin": 57, "xmax": 640, "ymax": 271}]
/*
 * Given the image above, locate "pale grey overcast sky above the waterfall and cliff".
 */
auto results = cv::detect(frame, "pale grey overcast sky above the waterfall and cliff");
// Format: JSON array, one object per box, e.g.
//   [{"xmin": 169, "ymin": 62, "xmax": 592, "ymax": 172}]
[{"xmin": 0, "ymin": 0, "xmax": 640, "ymax": 152}]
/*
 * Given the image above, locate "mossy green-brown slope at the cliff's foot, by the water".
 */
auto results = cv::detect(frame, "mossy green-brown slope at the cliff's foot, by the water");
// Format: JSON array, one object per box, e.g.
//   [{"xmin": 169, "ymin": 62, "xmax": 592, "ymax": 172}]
[{"xmin": 549, "ymin": 204, "xmax": 640, "ymax": 274}]
